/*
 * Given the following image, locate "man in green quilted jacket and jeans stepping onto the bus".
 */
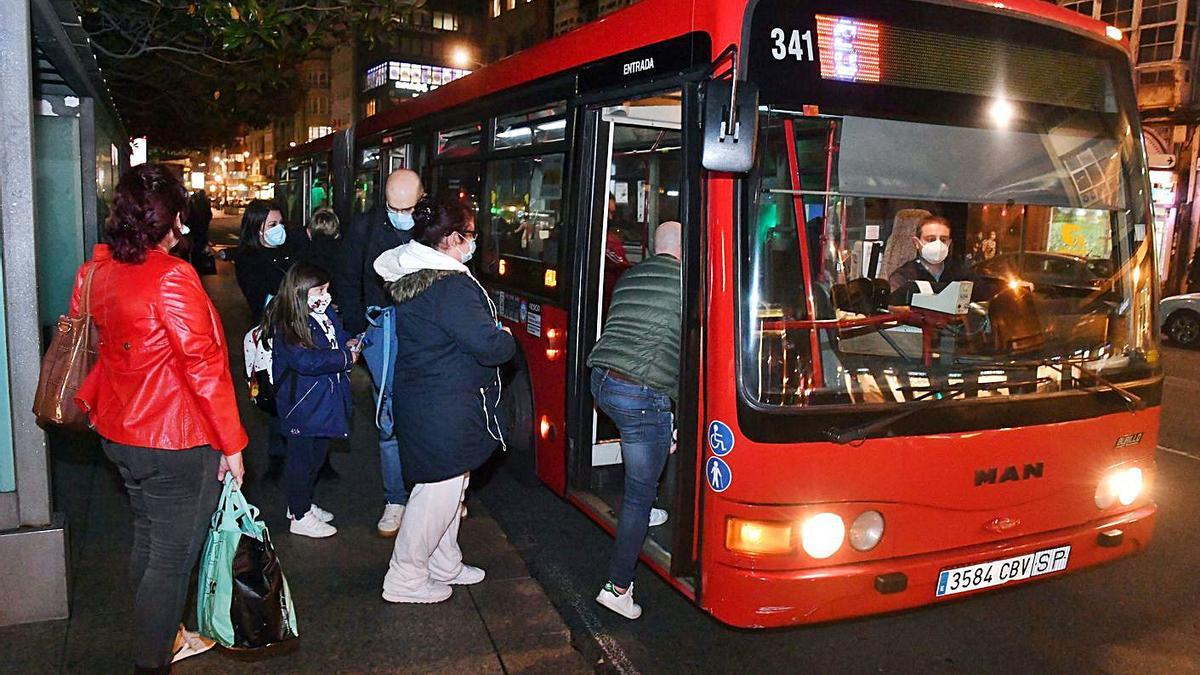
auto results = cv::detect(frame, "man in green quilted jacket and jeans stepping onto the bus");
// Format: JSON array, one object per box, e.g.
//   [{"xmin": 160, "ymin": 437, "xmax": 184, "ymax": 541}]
[{"xmin": 588, "ymin": 221, "xmax": 683, "ymax": 619}]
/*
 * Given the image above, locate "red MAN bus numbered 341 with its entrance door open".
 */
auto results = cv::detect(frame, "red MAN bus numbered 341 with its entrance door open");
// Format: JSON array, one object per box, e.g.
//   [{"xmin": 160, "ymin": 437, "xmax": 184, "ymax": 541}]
[{"xmin": 278, "ymin": 0, "xmax": 1162, "ymax": 627}]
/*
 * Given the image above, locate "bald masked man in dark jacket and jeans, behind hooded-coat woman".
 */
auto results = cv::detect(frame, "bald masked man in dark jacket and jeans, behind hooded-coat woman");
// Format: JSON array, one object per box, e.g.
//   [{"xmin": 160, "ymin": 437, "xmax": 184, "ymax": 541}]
[{"xmin": 332, "ymin": 169, "xmax": 425, "ymax": 537}]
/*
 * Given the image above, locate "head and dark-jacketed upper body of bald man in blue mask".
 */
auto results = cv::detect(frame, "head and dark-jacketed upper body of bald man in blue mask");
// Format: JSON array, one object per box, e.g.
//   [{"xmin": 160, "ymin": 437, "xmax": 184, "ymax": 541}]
[{"xmin": 332, "ymin": 169, "xmax": 425, "ymax": 334}]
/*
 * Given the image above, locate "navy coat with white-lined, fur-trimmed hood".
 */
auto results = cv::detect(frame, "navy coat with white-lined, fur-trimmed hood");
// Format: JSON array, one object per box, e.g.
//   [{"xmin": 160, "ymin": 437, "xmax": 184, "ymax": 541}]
[{"xmin": 374, "ymin": 241, "xmax": 516, "ymax": 483}]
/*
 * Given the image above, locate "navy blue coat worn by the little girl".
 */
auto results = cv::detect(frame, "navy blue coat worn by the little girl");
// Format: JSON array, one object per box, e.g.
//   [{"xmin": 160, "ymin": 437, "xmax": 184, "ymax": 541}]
[{"xmin": 271, "ymin": 307, "xmax": 354, "ymax": 438}]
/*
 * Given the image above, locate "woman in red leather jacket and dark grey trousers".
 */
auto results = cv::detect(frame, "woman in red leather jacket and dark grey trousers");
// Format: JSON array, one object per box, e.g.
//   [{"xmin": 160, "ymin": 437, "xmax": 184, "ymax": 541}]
[{"xmin": 71, "ymin": 165, "xmax": 247, "ymax": 673}]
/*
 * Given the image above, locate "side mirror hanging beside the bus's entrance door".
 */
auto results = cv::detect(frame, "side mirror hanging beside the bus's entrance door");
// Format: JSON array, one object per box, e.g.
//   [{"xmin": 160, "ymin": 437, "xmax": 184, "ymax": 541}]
[{"xmin": 701, "ymin": 79, "xmax": 758, "ymax": 173}]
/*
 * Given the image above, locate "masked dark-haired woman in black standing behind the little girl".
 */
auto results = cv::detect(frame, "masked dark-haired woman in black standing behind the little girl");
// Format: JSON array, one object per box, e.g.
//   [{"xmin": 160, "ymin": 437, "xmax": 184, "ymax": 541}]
[{"xmin": 234, "ymin": 199, "xmax": 296, "ymax": 323}]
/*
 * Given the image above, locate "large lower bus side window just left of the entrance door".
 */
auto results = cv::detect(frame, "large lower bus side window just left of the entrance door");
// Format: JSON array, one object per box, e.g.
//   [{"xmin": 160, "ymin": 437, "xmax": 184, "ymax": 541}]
[{"xmin": 479, "ymin": 154, "xmax": 564, "ymax": 284}]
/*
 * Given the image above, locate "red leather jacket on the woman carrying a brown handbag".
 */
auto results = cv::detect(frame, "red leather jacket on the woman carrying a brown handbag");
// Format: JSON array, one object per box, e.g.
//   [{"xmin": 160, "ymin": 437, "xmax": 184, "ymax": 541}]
[{"xmin": 71, "ymin": 244, "xmax": 247, "ymax": 455}]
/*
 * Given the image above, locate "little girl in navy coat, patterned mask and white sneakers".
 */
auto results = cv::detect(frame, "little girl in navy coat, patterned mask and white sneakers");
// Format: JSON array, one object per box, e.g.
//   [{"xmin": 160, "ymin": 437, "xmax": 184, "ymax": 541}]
[{"xmin": 263, "ymin": 263, "xmax": 359, "ymax": 538}]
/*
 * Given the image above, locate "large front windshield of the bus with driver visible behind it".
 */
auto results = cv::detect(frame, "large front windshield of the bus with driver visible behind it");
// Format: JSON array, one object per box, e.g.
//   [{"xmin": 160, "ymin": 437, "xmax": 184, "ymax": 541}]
[{"xmin": 739, "ymin": 79, "xmax": 1157, "ymax": 407}]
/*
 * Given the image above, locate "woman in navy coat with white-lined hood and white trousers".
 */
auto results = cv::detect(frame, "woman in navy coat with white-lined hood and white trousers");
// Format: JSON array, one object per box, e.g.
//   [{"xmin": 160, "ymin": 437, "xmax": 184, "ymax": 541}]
[{"xmin": 374, "ymin": 201, "xmax": 516, "ymax": 603}]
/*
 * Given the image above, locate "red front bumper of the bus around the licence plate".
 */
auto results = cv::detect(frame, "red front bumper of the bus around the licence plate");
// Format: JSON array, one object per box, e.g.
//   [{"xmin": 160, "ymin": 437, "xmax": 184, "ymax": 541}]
[{"xmin": 701, "ymin": 503, "xmax": 1157, "ymax": 628}]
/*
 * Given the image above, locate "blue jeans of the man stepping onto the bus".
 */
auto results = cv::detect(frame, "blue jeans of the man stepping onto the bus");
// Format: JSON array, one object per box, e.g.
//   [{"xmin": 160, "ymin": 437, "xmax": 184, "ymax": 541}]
[{"xmin": 592, "ymin": 368, "xmax": 671, "ymax": 589}]
